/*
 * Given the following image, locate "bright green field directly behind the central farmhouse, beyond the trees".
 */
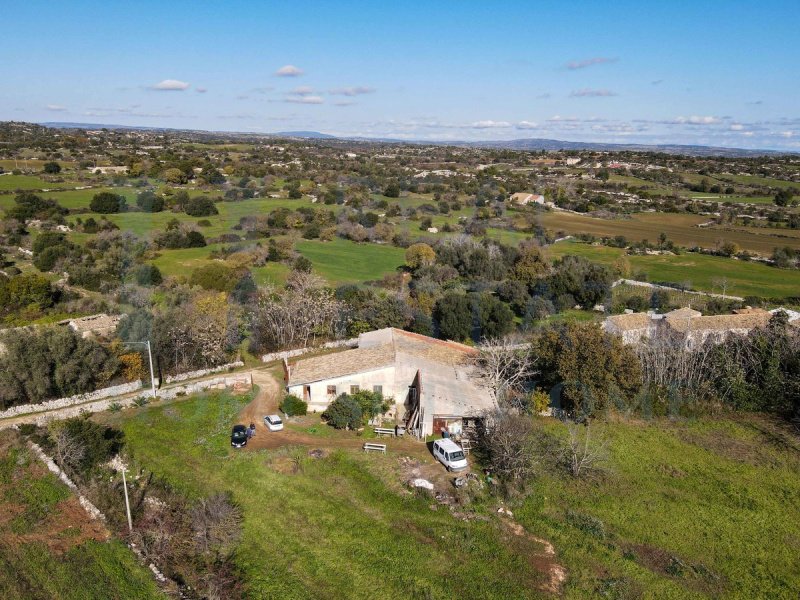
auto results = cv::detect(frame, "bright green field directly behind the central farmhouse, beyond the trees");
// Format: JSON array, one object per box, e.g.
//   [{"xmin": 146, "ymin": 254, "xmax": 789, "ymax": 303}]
[{"xmin": 296, "ymin": 238, "xmax": 405, "ymax": 285}]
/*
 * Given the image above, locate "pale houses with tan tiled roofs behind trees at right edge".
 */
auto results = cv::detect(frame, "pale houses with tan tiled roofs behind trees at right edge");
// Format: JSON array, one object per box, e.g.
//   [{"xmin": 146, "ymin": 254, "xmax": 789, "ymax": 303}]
[{"xmin": 603, "ymin": 308, "xmax": 800, "ymax": 349}]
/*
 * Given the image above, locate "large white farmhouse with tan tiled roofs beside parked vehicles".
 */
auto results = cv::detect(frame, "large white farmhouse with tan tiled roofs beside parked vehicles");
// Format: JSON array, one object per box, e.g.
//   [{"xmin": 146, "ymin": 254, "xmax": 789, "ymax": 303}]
[{"xmin": 285, "ymin": 328, "xmax": 494, "ymax": 435}]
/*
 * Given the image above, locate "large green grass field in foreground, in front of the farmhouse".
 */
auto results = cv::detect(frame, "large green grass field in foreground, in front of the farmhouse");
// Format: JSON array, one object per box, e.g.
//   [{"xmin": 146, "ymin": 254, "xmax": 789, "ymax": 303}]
[{"xmin": 96, "ymin": 395, "xmax": 800, "ymax": 599}]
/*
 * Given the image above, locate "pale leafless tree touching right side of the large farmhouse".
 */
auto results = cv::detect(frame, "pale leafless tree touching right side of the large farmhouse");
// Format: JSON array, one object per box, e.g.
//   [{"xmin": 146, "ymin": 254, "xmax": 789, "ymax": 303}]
[{"xmin": 475, "ymin": 337, "xmax": 537, "ymax": 410}]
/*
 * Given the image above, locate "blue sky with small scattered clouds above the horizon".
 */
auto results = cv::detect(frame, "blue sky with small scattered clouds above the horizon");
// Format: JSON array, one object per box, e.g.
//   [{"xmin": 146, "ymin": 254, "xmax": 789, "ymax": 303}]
[{"xmin": 0, "ymin": 0, "xmax": 800, "ymax": 150}]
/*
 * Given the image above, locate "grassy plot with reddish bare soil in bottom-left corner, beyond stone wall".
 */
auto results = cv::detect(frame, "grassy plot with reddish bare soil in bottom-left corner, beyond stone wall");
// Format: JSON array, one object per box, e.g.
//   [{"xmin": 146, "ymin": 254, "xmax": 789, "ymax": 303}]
[{"xmin": 0, "ymin": 430, "xmax": 164, "ymax": 600}]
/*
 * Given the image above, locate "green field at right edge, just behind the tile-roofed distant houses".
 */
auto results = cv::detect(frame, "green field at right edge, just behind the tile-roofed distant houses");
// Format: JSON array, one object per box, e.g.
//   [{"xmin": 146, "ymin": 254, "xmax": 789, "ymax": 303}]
[{"xmin": 547, "ymin": 241, "xmax": 800, "ymax": 298}]
